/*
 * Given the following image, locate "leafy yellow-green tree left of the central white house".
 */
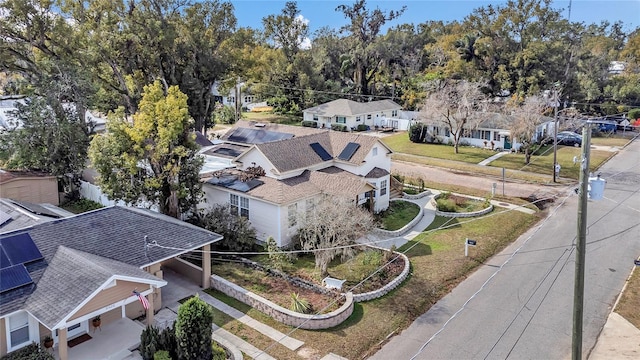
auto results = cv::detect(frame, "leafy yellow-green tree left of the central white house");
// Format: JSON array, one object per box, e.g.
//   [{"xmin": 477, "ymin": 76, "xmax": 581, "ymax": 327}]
[{"xmin": 89, "ymin": 81, "xmax": 202, "ymax": 217}]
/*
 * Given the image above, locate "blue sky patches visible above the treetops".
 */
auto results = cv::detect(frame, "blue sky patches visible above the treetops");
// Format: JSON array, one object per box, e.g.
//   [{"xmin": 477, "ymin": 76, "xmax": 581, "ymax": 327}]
[{"xmin": 229, "ymin": 0, "xmax": 640, "ymax": 34}]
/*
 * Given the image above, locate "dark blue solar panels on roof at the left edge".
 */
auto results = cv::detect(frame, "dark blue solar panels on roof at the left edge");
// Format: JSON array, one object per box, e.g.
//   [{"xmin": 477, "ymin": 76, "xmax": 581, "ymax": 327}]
[{"xmin": 0, "ymin": 233, "xmax": 43, "ymax": 293}]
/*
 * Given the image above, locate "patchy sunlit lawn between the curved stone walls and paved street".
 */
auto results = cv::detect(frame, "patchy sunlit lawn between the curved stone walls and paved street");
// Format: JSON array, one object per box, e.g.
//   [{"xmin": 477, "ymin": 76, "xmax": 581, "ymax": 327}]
[{"xmin": 212, "ymin": 210, "xmax": 538, "ymax": 359}]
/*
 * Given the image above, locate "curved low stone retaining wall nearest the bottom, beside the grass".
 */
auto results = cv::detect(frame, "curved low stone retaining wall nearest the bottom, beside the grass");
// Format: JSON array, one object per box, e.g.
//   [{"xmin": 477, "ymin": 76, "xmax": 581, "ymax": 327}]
[{"xmin": 211, "ymin": 275, "xmax": 354, "ymax": 330}]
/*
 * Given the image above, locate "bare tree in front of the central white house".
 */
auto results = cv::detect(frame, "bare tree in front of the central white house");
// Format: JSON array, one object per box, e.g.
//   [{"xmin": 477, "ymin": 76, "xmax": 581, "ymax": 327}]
[{"xmin": 298, "ymin": 195, "xmax": 374, "ymax": 277}]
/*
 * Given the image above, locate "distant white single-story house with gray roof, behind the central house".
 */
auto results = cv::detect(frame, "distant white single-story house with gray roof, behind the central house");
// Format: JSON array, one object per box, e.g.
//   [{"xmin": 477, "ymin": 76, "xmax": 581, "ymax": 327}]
[{"xmin": 302, "ymin": 99, "xmax": 409, "ymax": 130}]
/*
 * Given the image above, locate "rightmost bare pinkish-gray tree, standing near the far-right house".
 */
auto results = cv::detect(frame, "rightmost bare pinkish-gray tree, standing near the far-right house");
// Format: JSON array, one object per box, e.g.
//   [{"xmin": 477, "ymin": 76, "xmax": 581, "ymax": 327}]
[{"xmin": 509, "ymin": 96, "xmax": 549, "ymax": 164}]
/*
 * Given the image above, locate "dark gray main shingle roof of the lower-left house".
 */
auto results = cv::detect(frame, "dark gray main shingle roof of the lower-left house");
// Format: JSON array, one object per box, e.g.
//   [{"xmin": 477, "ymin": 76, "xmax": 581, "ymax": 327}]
[{"xmin": 0, "ymin": 206, "xmax": 222, "ymax": 316}]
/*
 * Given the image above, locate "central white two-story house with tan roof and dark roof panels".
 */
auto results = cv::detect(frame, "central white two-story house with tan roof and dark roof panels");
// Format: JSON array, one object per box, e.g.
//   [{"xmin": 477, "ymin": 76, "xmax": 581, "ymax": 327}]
[{"xmin": 202, "ymin": 122, "xmax": 391, "ymax": 247}]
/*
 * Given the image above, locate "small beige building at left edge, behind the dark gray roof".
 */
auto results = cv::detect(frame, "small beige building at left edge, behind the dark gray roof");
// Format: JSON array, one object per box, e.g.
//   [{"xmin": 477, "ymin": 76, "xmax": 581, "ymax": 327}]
[{"xmin": 0, "ymin": 170, "xmax": 60, "ymax": 205}]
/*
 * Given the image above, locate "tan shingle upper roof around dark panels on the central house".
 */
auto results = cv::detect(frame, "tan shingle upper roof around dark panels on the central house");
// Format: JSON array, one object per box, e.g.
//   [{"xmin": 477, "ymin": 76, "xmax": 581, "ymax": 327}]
[{"xmin": 244, "ymin": 131, "xmax": 384, "ymax": 173}]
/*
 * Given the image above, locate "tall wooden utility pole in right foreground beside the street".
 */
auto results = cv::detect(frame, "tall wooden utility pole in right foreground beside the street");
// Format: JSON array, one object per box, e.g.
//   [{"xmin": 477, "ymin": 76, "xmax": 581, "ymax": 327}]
[{"xmin": 571, "ymin": 122, "xmax": 591, "ymax": 360}]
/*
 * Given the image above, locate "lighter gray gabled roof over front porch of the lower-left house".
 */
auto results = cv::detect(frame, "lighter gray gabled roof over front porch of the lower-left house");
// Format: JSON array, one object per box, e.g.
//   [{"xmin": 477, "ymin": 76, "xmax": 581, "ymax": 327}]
[{"xmin": 24, "ymin": 246, "xmax": 164, "ymax": 329}]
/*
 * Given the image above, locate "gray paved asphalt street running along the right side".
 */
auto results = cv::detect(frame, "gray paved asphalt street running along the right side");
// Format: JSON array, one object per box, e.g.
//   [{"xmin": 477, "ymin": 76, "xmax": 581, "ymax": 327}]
[{"xmin": 370, "ymin": 139, "xmax": 640, "ymax": 360}]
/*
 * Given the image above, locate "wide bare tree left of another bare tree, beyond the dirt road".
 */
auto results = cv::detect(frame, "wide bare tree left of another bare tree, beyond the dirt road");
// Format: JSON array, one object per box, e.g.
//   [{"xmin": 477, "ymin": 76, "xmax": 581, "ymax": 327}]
[{"xmin": 420, "ymin": 80, "xmax": 487, "ymax": 154}]
